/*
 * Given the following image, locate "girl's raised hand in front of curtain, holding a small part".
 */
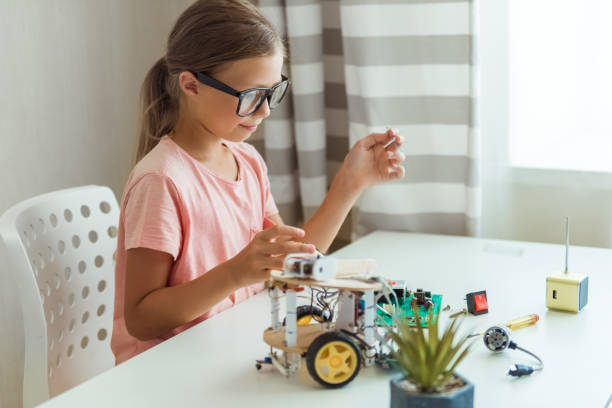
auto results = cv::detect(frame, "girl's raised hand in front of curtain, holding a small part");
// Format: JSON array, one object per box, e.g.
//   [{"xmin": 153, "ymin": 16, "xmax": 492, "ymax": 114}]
[{"xmin": 341, "ymin": 129, "xmax": 406, "ymax": 190}]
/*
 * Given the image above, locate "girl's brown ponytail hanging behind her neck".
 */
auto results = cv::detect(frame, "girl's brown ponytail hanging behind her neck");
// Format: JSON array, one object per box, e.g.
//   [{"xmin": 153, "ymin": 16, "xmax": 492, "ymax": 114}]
[{"xmin": 136, "ymin": 56, "xmax": 178, "ymax": 162}]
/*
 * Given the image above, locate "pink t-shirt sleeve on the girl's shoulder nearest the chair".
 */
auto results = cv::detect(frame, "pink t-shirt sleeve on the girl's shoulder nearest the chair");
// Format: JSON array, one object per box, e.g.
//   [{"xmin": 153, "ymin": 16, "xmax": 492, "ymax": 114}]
[{"xmin": 124, "ymin": 174, "xmax": 182, "ymax": 260}]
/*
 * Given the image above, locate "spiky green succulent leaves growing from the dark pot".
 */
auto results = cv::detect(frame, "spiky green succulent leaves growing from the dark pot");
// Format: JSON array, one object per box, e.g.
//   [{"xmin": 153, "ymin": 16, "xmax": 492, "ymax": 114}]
[{"xmin": 389, "ymin": 307, "xmax": 473, "ymax": 393}]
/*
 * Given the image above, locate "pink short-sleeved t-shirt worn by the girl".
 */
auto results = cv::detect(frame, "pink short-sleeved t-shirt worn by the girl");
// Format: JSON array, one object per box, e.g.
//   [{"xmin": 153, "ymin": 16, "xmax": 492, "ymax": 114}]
[{"xmin": 111, "ymin": 136, "xmax": 278, "ymax": 364}]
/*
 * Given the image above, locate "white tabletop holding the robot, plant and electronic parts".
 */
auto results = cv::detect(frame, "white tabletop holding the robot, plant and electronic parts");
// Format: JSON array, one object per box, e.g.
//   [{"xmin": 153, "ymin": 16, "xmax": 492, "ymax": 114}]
[{"xmin": 45, "ymin": 232, "xmax": 612, "ymax": 408}]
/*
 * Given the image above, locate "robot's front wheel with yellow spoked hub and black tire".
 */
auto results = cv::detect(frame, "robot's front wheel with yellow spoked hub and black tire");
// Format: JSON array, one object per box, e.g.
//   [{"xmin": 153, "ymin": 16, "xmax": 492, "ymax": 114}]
[{"xmin": 306, "ymin": 332, "xmax": 361, "ymax": 388}]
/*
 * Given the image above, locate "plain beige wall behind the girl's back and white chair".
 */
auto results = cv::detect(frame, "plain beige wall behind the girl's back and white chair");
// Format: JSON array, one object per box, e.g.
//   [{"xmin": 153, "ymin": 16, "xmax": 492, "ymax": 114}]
[{"xmin": 0, "ymin": 0, "xmax": 190, "ymax": 407}]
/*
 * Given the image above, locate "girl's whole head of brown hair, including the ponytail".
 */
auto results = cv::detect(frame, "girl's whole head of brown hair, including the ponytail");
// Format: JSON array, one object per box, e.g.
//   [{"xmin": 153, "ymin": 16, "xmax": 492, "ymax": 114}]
[{"xmin": 136, "ymin": 0, "xmax": 285, "ymax": 161}]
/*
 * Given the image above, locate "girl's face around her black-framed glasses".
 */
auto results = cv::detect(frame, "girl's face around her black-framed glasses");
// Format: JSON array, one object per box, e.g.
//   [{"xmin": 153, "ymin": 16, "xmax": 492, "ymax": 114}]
[{"xmin": 184, "ymin": 53, "xmax": 286, "ymax": 142}]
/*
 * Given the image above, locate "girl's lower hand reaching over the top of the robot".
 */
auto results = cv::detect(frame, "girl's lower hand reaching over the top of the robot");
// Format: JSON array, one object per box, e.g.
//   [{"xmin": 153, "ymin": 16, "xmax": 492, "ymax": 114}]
[{"xmin": 232, "ymin": 225, "xmax": 315, "ymax": 287}]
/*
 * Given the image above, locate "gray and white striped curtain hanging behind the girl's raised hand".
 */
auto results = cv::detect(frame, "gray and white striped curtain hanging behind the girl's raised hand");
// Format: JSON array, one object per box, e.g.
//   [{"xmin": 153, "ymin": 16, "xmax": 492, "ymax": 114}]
[{"xmin": 255, "ymin": 0, "xmax": 481, "ymax": 245}]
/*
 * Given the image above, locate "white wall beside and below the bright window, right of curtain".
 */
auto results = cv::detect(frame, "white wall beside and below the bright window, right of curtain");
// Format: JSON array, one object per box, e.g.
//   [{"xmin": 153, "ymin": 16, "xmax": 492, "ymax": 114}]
[{"xmin": 479, "ymin": 0, "xmax": 612, "ymax": 249}]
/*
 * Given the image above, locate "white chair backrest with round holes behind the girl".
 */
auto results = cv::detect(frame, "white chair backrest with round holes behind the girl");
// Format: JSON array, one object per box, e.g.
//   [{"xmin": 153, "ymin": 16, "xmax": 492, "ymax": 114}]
[{"xmin": 0, "ymin": 186, "xmax": 119, "ymax": 407}]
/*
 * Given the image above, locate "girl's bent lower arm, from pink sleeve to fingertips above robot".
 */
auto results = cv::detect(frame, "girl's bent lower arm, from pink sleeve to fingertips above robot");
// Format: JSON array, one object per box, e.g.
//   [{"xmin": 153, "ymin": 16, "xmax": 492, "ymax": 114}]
[{"xmin": 124, "ymin": 225, "xmax": 314, "ymax": 340}]
